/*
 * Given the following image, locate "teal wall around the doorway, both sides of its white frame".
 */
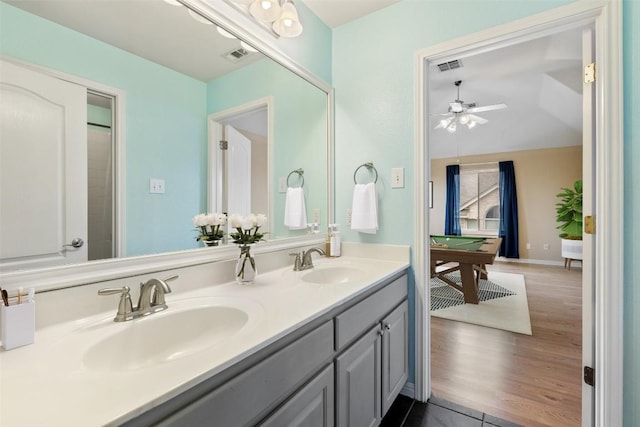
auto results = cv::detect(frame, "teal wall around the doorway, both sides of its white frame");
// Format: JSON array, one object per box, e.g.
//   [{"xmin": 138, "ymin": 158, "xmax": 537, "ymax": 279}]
[{"xmin": 332, "ymin": 0, "xmax": 640, "ymax": 426}]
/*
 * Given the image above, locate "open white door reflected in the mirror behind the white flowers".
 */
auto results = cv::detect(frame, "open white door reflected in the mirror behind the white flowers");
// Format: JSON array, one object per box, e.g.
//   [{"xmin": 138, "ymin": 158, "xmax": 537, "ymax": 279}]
[{"xmin": 225, "ymin": 125, "xmax": 251, "ymax": 215}]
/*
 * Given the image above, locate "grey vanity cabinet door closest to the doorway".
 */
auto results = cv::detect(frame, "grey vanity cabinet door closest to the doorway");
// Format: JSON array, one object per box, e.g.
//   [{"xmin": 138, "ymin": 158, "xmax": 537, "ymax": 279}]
[{"xmin": 382, "ymin": 301, "xmax": 409, "ymax": 416}]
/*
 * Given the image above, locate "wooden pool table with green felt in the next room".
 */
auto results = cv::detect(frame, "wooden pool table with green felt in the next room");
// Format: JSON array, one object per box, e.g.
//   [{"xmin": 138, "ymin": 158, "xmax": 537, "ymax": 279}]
[{"xmin": 430, "ymin": 235, "xmax": 502, "ymax": 304}]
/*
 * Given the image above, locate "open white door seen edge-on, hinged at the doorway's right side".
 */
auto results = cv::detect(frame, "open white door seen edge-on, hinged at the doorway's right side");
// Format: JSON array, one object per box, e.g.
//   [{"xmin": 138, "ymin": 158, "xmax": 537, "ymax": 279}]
[{"xmin": 582, "ymin": 29, "xmax": 596, "ymax": 426}]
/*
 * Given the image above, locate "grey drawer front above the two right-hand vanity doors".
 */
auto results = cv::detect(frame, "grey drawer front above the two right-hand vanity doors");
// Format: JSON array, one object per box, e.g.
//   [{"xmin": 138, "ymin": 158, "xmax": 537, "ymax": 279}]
[{"xmin": 335, "ymin": 274, "xmax": 407, "ymax": 351}]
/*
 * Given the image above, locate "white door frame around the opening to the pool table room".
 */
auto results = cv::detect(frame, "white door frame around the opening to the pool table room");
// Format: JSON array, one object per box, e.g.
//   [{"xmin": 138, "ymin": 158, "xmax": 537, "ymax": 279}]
[{"xmin": 412, "ymin": 0, "xmax": 624, "ymax": 426}]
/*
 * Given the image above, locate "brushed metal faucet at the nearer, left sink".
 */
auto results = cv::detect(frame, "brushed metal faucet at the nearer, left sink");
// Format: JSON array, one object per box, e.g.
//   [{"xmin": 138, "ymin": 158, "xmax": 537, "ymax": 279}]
[{"xmin": 98, "ymin": 276, "xmax": 178, "ymax": 322}]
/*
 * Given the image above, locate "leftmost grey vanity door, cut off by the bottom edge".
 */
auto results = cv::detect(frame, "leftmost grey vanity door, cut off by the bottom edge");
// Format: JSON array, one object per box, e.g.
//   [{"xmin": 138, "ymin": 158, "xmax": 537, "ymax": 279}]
[{"xmin": 260, "ymin": 365, "xmax": 334, "ymax": 427}]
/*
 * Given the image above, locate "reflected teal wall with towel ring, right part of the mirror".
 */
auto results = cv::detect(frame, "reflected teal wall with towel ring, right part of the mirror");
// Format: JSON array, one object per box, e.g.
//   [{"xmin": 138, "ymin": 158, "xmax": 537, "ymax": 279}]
[{"xmin": 208, "ymin": 59, "xmax": 328, "ymax": 237}]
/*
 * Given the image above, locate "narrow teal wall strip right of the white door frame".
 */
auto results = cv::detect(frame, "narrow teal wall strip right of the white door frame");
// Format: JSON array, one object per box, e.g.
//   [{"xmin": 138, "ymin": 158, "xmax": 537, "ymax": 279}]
[{"xmin": 622, "ymin": 0, "xmax": 640, "ymax": 427}]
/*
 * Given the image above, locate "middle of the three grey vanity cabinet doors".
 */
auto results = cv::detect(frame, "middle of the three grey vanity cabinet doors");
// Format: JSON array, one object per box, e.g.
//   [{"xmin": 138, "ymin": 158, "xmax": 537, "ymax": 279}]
[{"xmin": 336, "ymin": 325, "xmax": 382, "ymax": 427}]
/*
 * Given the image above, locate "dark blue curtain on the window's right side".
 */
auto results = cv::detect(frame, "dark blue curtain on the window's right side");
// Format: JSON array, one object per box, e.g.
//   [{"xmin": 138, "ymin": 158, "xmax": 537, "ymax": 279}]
[{"xmin": 498, "ymin": 160, "xmax": 520, "ymax": 258}]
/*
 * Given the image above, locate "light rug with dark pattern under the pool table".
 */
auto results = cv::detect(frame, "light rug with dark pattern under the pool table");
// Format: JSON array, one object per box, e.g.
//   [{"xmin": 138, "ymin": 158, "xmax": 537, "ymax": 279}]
[{"xmin": 431, "ymin": 271, "xmax": 532, "ymax": 335}]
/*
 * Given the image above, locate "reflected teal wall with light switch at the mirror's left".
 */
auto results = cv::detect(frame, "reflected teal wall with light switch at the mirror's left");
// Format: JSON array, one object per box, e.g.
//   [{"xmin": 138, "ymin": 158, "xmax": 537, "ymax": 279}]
[{"xmin": 0, "ymin": 2, "xmax": 207, "ymax": 255}]
